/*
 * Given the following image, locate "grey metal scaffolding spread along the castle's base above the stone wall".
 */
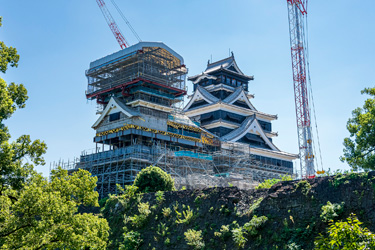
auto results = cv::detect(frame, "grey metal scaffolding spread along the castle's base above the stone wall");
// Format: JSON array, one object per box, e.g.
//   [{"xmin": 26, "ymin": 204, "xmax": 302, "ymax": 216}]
[{"xmin": 51, "ymin": 143, "xmax": 292, "ymax": 198}]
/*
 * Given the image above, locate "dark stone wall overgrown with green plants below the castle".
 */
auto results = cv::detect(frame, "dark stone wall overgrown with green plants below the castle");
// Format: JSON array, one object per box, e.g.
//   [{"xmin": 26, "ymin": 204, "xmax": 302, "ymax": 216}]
[{"xmin": 102, "ymin": 169, "xmax": 375, "ymax": 249}]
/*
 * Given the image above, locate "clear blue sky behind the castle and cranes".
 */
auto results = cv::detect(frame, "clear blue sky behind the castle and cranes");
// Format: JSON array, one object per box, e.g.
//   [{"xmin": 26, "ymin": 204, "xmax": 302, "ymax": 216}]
[{"xmin": 0, "ymin": 0, "xmax": 375, "ymax": 175}]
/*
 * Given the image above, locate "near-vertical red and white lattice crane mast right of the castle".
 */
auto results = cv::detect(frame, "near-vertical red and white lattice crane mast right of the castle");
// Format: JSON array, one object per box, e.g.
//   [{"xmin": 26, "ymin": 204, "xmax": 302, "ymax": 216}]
[{"xmin": 287, "ymin": 0, "xmax": 315, "ymax": 178}]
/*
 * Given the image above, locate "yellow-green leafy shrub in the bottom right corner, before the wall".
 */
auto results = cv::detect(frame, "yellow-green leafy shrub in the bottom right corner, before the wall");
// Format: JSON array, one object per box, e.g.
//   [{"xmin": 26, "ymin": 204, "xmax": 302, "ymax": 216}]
[{"xmin": 314, "ymin": 214, "xmax": 375, "ymax": 250}]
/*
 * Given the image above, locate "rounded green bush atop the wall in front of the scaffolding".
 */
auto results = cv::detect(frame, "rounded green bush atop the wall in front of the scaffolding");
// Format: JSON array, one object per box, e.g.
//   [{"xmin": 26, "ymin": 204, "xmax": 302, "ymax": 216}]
[{"xmin": 134, "ymin": 166, "xmax": 174, "ymax": 193}]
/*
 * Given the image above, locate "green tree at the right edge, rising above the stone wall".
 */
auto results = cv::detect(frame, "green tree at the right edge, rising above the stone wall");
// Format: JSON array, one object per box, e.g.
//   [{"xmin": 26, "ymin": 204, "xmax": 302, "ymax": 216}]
[{"xmin": 340, "ymin": 88, "xmax": 375, "ymax": 170}]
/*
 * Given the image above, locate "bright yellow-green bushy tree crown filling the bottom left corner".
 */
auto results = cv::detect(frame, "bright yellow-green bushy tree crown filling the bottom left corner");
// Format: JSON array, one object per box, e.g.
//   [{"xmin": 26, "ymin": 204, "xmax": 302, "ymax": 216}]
[{"xmin": 0, "ymin": 168, "xmax": 109, "ymax": 249}]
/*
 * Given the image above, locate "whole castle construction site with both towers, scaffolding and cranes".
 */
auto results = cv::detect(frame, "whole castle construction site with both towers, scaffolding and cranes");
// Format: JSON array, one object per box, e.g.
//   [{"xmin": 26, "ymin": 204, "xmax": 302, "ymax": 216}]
[{"xmin": 51, "ymin": 0, "xmax": 326, "ymax": 198}]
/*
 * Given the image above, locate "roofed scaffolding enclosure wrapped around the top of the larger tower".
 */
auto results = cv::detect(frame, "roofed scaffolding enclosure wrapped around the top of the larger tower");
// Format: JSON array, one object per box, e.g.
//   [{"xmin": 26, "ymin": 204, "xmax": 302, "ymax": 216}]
[{"xmin": 86, "ymin": 47, "xmax": 187, "ymax": 99}]
